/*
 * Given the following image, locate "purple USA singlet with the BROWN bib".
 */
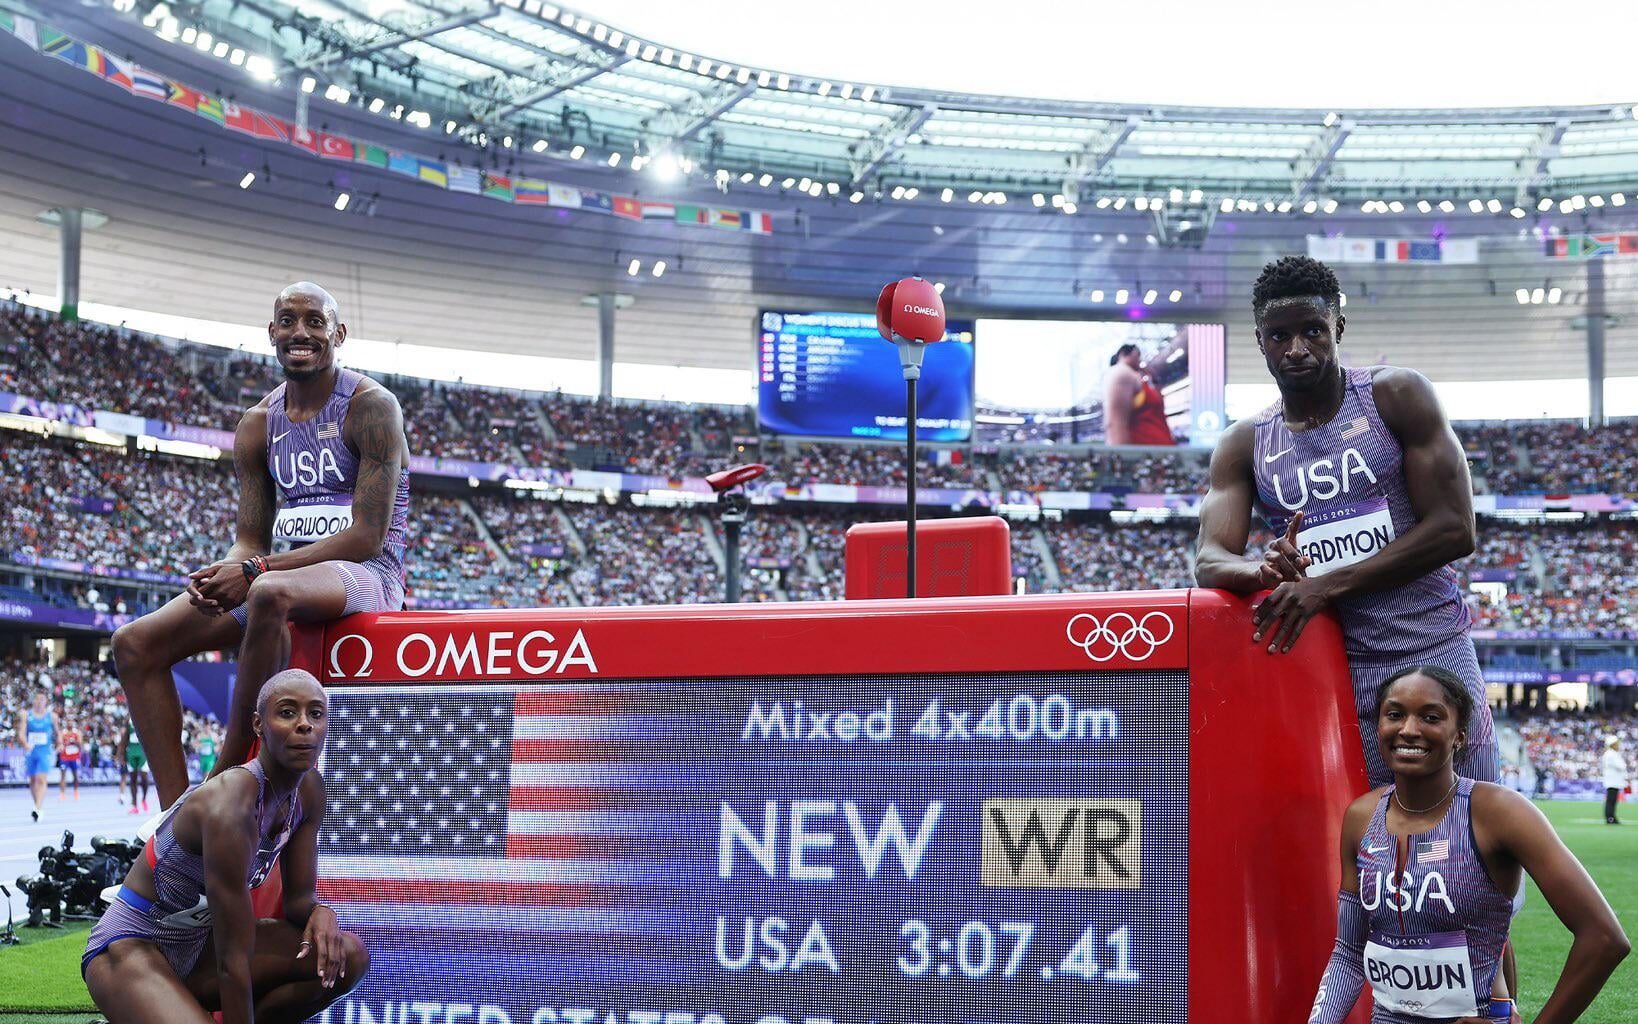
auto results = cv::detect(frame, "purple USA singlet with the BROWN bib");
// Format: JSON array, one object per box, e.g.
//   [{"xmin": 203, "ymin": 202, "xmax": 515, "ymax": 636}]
[{"xmin": 1358, "ymin": 777, "xmax": 1514, "ymax": 1024}]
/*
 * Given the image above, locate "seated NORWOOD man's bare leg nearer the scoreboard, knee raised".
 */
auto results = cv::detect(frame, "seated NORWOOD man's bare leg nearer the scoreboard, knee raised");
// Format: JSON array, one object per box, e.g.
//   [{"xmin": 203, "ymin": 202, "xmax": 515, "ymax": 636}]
[{"xmin": 211, "ymin": 564, "xmax": 347, "ymax": 775}]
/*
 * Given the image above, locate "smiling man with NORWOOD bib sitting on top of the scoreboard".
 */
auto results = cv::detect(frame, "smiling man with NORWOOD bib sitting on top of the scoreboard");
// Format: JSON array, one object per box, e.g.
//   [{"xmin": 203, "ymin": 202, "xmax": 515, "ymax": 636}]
[{"xmin": 113, "ymin": 282, "xmax": 410, "ymax": 806}]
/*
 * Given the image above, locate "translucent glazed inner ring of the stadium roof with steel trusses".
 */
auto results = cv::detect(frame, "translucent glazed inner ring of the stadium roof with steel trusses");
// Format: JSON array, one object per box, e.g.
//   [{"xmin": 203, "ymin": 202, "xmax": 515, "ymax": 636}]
[{"xmin": 83, "ymin": 0, "xmax": 1638, "ymax": 215}]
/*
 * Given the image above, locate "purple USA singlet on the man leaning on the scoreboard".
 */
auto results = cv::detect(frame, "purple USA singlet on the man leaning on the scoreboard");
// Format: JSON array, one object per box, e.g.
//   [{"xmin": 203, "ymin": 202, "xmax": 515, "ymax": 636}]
[{"xmin": 1251, "ymin": 367, "xmax": 1482, "ymax": 658}]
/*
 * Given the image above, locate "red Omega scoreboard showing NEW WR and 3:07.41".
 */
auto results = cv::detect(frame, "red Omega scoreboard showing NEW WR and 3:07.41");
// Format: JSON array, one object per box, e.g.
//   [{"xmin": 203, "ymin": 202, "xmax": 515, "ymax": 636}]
[{"xmin": 293, "ymin": 590, "xmax": 1364, "ymax": 1024}]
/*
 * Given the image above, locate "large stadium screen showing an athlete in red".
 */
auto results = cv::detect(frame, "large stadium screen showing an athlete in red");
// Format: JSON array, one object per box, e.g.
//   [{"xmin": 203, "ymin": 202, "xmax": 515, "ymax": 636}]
[{"xmin": 976, "ymin": 318, "xmax": 1227, "ymax": 447}]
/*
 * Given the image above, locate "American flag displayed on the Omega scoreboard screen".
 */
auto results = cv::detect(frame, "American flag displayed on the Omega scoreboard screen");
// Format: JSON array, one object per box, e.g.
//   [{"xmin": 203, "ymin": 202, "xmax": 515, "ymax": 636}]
[{"xmin": 319, "ymin": 686, "xmax": 698, "ymax": 936}]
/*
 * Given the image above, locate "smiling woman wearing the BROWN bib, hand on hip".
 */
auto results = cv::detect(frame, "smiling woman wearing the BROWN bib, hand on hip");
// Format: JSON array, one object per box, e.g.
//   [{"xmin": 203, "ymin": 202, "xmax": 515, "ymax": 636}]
[{"xmin": 1309, "ymin": 665, "xmax": 1631, "ymax": 1024}]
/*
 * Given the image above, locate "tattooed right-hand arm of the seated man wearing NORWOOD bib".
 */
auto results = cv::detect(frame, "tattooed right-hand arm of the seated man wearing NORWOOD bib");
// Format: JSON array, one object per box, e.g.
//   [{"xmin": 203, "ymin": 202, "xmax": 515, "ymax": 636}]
[{"xmin": 267, "ymin": 385, "xmax": 408, "ymax": 570}]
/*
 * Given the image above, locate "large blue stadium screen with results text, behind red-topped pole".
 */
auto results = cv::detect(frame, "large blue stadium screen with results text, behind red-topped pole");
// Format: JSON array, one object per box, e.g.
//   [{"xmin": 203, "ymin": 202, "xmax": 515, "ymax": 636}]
[{"xmin": 757, "ymin": 310, "xmax": 973, "ymax": 441}]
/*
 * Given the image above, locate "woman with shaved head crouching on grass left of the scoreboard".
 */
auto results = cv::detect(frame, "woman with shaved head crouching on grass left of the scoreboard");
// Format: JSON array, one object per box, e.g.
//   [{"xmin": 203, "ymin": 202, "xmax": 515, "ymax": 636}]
[{"xmin": 80, "ymin": 668, "xmax": 369, "ymax": 1024}]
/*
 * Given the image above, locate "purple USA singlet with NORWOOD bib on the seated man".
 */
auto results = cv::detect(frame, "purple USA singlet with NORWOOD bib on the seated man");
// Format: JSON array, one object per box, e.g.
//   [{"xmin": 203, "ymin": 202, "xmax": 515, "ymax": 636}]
[{"xmin": 267, "ymin": 369, "xmax": 410, "ymax": 582}]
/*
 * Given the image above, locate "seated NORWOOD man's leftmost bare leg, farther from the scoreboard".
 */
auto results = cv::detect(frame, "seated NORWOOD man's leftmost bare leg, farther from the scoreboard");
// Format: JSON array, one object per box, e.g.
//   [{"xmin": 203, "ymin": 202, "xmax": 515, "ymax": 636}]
[{"xmin": 113, "ymin": 595, "xmax": 242, "ymax": 809}]
